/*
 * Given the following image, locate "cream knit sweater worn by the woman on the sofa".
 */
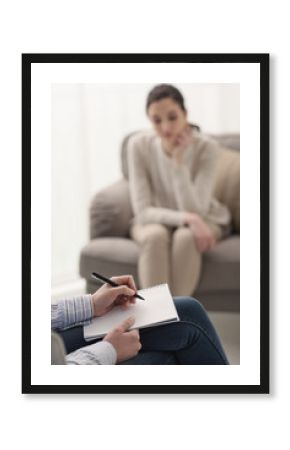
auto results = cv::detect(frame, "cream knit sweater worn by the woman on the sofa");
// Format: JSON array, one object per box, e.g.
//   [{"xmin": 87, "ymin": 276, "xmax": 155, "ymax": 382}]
[{"xmin": 128, "ymin": 130, "xmax": 230, "ymax": 227}]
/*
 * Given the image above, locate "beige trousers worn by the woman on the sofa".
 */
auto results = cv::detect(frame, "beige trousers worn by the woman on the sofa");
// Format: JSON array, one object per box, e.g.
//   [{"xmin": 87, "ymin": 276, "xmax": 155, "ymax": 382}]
[{"xmin": 130, "ymin": 224, "xmax": 222, "ymax": 296}]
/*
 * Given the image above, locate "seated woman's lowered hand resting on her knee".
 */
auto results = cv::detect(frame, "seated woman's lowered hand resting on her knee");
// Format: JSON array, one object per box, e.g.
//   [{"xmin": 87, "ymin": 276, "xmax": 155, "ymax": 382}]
[{"xmin": 184, "ymin": 213, "xmax": 216, "ymax": 253}]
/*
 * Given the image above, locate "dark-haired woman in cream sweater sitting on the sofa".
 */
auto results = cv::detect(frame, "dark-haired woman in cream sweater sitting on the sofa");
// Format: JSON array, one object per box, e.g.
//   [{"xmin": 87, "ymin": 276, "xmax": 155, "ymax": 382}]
[{"xmin": 128, "ymin": 84, "xmax": 231, "ymax": 296}]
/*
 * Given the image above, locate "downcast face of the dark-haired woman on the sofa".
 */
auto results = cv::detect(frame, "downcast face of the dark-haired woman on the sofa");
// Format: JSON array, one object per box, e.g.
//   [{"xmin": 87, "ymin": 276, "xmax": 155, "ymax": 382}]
[{"xmin": 148, "ymin": 97, "xmax": 187, "ymax": 146}]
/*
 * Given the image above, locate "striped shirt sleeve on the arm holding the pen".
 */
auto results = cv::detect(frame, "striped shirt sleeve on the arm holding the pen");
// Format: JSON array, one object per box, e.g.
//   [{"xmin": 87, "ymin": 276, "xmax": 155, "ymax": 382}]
[{"xmin": 51, "ymin": 294, "xmax": 93, "ymax": 330}]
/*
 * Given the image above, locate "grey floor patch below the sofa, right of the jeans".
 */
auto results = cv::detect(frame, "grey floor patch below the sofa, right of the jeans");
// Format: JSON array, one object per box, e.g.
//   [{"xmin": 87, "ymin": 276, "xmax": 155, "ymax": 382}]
[{"xmin": 208, "ymin": 311, "xmax": 240, "ymax": 364}]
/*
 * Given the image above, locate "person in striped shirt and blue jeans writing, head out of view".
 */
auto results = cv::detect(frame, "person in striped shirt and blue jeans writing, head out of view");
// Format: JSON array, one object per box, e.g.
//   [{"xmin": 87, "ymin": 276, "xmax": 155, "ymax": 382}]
[{"xmin": 51, "ymin": 275, "xmax": 228, "ymax": 365}]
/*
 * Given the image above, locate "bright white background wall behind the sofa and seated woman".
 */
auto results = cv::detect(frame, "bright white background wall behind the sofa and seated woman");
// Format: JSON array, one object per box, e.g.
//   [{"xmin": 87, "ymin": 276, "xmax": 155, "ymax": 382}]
[{"xmin": 51, "ymin": 84, "xmax": 239, "ymax": 297}]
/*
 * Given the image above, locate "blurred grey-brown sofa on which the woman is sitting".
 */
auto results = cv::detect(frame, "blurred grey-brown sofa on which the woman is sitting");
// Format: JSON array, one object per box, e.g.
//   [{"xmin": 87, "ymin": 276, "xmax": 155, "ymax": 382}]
[{"xmin": 80, "ymin": 133, "xmax": 240, "ymax": 311}]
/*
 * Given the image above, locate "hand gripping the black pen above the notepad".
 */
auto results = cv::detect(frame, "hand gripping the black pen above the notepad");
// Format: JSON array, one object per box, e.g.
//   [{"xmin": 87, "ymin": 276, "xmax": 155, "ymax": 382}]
[{"xmin": 92, "ymin": 275, "xmax": 137, "ymax": 317}]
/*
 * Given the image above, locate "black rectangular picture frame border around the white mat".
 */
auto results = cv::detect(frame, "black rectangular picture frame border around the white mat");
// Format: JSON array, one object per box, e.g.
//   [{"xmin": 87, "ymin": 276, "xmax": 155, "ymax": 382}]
[{"xmin": 22, "ymin": 53, "xmax": 270, "ymax": 394}]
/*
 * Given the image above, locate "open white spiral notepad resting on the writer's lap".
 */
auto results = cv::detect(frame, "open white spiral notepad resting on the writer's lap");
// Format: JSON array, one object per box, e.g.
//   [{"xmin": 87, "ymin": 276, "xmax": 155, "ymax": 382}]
[{"xmin": 84, "ymin": 284, "xmax": 179, "ymax": 341}]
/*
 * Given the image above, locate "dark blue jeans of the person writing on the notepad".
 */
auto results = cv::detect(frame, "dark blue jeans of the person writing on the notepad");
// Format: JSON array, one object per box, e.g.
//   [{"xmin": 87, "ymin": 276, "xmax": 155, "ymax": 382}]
[{"xmin": 61, "ymin": 297, "xmax": 228, "ymax": 365}]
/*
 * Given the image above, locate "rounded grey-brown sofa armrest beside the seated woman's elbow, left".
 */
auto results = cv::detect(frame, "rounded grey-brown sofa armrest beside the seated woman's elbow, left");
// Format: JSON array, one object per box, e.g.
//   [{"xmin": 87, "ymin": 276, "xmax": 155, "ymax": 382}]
[{"xmin": 90, "ymin": 179, "xmax": 133, "ymax": 239}]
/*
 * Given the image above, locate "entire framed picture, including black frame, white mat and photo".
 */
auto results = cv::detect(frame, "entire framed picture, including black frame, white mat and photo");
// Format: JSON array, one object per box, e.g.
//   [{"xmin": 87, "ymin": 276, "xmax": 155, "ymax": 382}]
[{"xmin": 22, "ymin": 53, "xmax": 269, "ymax": 394}]
